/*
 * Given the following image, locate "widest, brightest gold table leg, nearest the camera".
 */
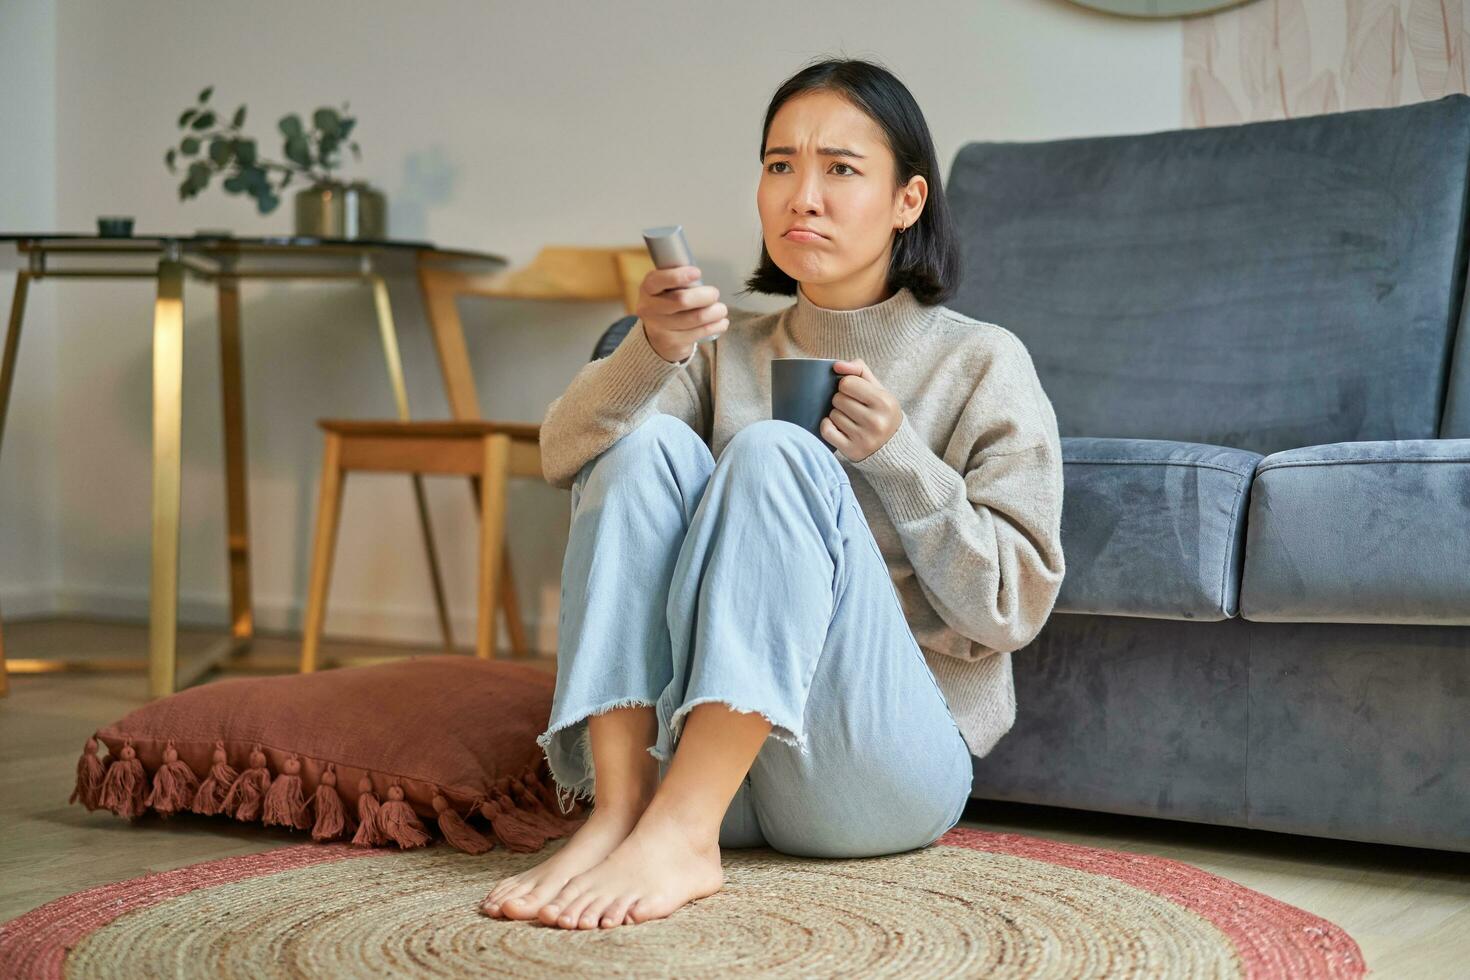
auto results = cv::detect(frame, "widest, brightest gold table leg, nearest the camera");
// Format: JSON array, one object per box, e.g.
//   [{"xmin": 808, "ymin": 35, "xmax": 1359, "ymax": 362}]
[{"xmin": 148, "ymin": 259, "xmax": 184, "ymax": 698}]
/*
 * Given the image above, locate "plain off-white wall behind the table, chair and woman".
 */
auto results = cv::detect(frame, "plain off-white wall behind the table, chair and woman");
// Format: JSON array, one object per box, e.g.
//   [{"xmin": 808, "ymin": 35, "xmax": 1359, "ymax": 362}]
[{"xmin": 0, "ymin": 0, "xmax": 1182, "ymax": 655}]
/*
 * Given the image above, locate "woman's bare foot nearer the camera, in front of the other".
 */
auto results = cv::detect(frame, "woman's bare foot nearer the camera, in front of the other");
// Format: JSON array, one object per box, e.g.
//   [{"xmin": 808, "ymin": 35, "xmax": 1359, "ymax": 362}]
[{"xmin": 538, "ymin": 808, "xmax": 725, "ymax": 929}]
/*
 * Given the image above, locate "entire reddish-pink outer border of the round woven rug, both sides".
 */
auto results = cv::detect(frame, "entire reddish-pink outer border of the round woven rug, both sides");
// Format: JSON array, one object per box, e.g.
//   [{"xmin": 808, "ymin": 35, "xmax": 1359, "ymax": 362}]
[{"xmin": 0, "ymin": 827, "xmax": 1369, "ymax": 980}]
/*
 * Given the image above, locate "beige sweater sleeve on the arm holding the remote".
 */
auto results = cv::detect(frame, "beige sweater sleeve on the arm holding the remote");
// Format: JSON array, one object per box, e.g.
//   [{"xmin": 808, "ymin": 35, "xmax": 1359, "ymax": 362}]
[{"xmin": 539, "ymin": 320, "xmax": 714, "ymax": 489}]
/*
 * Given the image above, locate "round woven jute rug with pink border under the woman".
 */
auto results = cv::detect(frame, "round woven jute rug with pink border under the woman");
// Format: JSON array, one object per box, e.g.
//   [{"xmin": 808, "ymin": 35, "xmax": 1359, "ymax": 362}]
[{"xmin": 0, "ymin": 827, "xmax": 1367, "ymax": 980}]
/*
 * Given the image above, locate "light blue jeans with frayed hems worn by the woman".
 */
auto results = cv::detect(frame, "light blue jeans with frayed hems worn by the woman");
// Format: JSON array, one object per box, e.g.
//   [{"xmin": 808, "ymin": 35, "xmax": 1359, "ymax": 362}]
[{"xmin": 537, "ymin": 414, "xmax": 973, "ymax": 858}]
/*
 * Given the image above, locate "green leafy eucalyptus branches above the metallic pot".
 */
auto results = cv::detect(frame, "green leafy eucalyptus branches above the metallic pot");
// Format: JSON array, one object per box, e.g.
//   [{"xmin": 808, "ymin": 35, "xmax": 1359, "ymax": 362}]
[{"xmin": 163, "ymin": 85, "xmax": 362, "ymax": 215}]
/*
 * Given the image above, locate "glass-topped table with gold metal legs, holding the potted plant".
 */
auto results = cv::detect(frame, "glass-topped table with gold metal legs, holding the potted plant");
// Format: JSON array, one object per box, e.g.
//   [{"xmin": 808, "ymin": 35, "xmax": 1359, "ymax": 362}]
[{"xmin": 0, "ymin": 232, "xmax": 509, "ymax": 696}]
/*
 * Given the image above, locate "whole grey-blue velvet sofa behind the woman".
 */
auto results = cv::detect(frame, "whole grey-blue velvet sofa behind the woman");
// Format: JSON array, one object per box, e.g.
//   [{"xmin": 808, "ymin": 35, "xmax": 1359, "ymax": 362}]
[{"xmin": 594, "ymin": 96, "xmax": 1470, "ymax": 851}]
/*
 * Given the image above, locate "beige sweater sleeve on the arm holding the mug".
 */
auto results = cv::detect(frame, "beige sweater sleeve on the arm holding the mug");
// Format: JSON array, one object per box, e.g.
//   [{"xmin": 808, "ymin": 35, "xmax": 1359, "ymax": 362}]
[{"xmin": 851, "ymin": 335, "xmax": 1066, "ymax": 658}]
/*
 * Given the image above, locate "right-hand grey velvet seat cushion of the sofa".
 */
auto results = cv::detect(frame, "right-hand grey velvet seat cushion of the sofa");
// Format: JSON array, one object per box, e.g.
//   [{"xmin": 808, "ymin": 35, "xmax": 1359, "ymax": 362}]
[{"xmin": 1241, "ymin": 439, "xmax": 1470, "ymax": 626}]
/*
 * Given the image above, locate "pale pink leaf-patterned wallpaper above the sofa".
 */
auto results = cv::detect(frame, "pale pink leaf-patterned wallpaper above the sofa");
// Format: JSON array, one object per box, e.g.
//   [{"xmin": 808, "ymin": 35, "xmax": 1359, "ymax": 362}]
[{"xmin": 1183, "ymin": 0, "xmax": 1470, "ymax": 126}]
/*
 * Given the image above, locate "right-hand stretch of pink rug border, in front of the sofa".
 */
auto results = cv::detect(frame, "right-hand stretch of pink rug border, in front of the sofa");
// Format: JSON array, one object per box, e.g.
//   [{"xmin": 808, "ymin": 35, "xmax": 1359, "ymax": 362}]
[{"xmin": 933, "ymin": 827, "xmax": 1370, "ymax": 980}]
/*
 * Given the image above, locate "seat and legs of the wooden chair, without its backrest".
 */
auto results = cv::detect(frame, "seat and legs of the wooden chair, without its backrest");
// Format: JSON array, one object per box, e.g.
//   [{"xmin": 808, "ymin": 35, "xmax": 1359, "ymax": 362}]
[{"xmin": 301, "ymin": 419, "xmax": 544, "ymax": 673}]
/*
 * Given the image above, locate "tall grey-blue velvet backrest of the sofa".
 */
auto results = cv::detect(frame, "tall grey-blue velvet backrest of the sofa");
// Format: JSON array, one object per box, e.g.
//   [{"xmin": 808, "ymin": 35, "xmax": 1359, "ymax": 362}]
[{"xmin": 947, "ymin": 94, "xmax": 1470, "ymax": 453}]
